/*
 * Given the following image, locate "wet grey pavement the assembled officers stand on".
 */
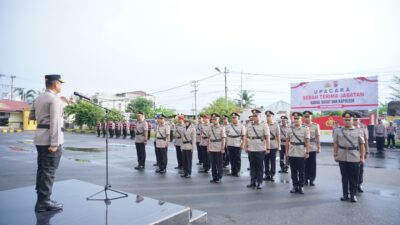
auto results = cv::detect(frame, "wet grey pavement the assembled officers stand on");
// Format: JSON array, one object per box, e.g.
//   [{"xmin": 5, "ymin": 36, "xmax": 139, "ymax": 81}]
[{"xmin": 0, "ymin": 132, "xmax": 400, "ymax": 224}]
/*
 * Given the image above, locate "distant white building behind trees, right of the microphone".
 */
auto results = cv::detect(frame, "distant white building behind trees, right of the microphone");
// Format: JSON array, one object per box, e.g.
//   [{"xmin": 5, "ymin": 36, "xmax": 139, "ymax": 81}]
[{"xmin": 92, "ymin": 91, "xmax": 155, "ymax": 112}]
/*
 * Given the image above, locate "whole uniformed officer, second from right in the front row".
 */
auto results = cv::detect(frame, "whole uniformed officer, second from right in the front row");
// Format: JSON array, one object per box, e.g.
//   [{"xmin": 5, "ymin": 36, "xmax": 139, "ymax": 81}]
[{"xmin": 286, "ymin": 112, "xmax": 310, "ymax": 194}]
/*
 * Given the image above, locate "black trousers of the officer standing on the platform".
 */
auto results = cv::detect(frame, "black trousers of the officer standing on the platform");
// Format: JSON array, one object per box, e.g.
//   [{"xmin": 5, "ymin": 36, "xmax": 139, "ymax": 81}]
[{"xmin": 36, "ymin": 145, "xmax": 62, "ymax": 202}]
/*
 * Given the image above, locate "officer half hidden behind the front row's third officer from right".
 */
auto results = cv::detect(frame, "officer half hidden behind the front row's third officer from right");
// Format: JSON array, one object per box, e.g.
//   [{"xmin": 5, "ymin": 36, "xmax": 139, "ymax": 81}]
[{"xmin": 264, "ymin": 110, "xmax": 281, "ymax": 182}]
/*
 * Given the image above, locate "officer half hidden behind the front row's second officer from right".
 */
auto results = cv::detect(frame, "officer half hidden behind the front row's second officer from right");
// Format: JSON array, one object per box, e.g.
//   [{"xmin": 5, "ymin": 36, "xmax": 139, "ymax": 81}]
[{"xmin": 303, "ymin": 111, "xmax": 321, "ymax": 186}]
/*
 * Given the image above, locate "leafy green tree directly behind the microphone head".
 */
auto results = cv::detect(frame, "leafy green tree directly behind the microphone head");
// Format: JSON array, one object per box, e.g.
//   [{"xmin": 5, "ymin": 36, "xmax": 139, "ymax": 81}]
[{"xmin": 64, "ymin": 101, "xmax": 105, "ymax": 129}]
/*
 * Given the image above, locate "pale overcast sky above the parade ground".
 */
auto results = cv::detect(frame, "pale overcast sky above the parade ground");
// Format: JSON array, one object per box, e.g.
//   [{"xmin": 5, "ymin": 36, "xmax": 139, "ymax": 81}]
[{"xmin": 0, "ymin": 0, "xmax": 400, "ymax": 112}]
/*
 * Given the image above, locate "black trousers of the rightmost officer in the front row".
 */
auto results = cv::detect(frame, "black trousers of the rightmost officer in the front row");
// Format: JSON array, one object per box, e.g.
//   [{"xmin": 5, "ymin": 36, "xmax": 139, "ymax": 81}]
[{"xmin": 339, "ymin": 161, "xmax": 360, "ymax": 196}]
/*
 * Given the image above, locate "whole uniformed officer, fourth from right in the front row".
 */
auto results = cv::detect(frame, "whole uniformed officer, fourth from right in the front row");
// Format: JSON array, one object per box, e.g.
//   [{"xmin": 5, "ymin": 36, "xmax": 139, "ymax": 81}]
[{"xmin": 207, "ymin": 113, "xmax": 226, "ymax": 183}]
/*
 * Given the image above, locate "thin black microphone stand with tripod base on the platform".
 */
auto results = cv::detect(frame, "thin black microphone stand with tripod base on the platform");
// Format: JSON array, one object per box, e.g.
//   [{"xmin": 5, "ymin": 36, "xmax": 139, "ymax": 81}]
[{"xmin": 76, "ymin": 98, "xmax": 128, "ymax": 203}]
